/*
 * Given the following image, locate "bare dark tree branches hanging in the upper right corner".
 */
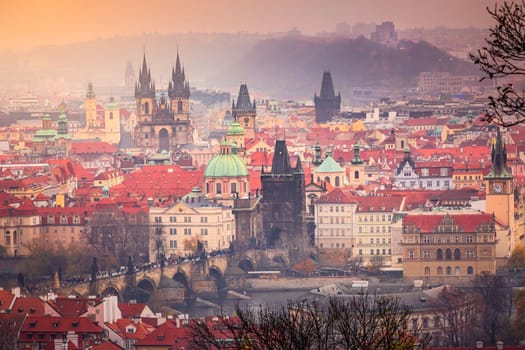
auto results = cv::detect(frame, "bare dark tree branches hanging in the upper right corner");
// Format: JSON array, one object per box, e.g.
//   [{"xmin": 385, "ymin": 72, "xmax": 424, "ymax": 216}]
[{"xmin": 470, "ymin": 0, "xmax": 525, "ymax": 127}]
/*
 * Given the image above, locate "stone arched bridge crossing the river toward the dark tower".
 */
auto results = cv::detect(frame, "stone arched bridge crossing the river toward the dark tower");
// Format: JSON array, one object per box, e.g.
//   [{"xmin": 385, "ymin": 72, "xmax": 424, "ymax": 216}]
[{"xmin": 56, "ymin": 249, "xmax": 290, "ymax": 302}]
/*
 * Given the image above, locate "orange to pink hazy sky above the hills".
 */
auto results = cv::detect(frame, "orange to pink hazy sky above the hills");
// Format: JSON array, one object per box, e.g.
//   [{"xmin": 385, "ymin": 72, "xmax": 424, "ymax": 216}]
[{"xmin": 0, "ymin": 0, "xmax": 501, "ymax": 51}]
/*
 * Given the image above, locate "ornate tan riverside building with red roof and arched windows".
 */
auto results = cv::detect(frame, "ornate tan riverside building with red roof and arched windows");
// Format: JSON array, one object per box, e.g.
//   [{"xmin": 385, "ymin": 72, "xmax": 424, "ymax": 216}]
[{"xmin": 401, "ymin": 212, "xmax": 496, "ymax": 282}]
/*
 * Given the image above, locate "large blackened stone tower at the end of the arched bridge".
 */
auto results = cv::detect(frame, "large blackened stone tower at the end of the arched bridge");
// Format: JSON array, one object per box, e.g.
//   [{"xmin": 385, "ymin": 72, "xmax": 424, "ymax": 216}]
[{"xmin": 261, "ymin": 140, "xmax": 307, "ymax": 261}]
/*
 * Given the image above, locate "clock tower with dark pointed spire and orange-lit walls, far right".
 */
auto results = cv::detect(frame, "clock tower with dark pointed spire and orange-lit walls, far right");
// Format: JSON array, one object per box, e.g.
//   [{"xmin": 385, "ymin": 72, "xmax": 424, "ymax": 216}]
[{"xmin": 485, "ymin": 128, "xmax": 516, "ymax": 254}]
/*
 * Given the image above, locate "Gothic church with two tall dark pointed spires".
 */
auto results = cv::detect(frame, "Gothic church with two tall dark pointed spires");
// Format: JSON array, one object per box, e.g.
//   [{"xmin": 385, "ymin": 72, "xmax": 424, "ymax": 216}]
[{"xmin": 134, "ymin": 53, "xmax": 192, "ymax": 152}]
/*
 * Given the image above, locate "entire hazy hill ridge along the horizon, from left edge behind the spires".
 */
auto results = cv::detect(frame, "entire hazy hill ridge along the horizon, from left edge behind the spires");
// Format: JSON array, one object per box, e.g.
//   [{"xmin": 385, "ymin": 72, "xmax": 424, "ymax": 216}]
[{"xmin": 0, "ymin": 33, "xmax": 477, "ymax": 100}]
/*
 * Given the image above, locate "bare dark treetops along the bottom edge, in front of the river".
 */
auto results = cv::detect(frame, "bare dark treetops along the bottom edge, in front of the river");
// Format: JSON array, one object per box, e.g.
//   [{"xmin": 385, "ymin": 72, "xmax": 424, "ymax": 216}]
[{"xmin": 186, "ymin": 294, "xmax": 427, "ymax": 350}]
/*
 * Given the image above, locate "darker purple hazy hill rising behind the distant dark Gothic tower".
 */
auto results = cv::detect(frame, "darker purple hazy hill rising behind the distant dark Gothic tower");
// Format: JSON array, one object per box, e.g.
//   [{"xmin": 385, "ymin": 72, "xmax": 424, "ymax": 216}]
[{"xmin": 210, "ymin": 37, "xmax": 478, "ymax": 99}]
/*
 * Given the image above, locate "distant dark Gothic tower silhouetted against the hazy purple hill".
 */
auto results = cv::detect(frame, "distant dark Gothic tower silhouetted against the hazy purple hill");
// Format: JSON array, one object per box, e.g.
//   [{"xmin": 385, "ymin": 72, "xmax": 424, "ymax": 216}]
[{"xmin": 314, "ymin": 71, "xmax": 341, "ymax": 123}]
